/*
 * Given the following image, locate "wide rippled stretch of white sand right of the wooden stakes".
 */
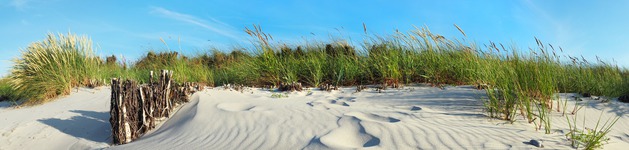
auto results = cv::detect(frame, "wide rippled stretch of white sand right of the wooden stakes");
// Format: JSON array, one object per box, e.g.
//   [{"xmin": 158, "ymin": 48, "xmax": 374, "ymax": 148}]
[{"xmin": 110, "ymin": 87, "xmax": 624, "ymax": 149}]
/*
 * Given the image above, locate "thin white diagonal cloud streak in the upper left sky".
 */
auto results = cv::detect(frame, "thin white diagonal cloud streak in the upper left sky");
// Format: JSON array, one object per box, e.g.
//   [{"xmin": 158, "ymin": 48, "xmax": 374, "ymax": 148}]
[{"xmin": 151, "ymin": 7, "xmax": 242, "ymax": 40}]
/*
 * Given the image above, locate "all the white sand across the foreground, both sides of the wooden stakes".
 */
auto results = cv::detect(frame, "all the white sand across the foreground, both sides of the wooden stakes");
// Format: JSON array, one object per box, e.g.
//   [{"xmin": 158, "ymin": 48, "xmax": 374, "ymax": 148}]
[{"xmin": 0, "ymin": 86, "xmax": 629, "ymax": 149}]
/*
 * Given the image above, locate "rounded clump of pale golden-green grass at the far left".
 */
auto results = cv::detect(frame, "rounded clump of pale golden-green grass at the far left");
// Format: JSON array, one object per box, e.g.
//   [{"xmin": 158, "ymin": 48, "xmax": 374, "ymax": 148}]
[{"xmin": 10, "ymin": 34, "xmax": 102, "ymax": 104}]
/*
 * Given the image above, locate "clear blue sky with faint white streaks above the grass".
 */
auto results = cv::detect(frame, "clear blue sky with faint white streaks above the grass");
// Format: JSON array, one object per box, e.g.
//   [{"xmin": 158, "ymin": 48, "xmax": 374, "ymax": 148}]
[{"xmin": 0, "ymin": 0, "xmax": 629, "ymax": 75}]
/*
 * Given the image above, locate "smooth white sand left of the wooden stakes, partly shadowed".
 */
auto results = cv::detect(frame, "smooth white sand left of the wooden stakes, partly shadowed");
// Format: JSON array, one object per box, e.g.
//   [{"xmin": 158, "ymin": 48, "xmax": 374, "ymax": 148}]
[{"xmin": 0, "ymin": 89, "xmax": 112, "ymax": 150}]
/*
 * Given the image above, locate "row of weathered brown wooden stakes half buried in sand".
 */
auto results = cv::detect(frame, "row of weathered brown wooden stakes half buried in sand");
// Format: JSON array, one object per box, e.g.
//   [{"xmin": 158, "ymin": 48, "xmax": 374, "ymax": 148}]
[{"xmin": 109, "ymin": 70, "xmax": 200, "ymax": 144}]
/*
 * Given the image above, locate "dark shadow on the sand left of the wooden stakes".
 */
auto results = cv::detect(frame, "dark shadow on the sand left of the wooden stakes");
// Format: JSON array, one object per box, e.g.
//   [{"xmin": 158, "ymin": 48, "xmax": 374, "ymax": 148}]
[{"xmin": 38, "ymin": 110, "xmax": 111, "ymax": 143}]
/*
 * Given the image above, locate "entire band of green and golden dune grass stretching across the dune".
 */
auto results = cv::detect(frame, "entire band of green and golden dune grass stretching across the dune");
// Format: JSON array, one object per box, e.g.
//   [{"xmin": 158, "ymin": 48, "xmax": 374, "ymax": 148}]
[{"xmin": 6, "ymin": 26, "xmax": 629, "ymax": 144}]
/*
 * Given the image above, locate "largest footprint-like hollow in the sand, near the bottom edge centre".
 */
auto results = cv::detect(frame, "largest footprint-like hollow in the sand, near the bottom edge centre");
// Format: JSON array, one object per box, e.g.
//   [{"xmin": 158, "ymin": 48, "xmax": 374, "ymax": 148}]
[{"xmin": 319, "ymin": 116, "xmax": 380, "ymax": 149}]
